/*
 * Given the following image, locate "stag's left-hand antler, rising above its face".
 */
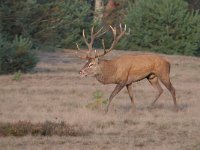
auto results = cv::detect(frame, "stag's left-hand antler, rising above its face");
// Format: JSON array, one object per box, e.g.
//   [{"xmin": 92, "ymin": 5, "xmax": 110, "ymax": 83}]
[{"xmin": 76, "ymin": 26, "xmax": 106, "ymax": 59}]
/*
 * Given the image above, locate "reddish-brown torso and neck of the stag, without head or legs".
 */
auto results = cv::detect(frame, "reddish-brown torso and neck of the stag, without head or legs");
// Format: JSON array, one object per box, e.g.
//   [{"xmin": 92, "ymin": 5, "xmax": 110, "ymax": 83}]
[{"xmin": 96, "ymin": 55, "xmax": 169, "ymax": 84}]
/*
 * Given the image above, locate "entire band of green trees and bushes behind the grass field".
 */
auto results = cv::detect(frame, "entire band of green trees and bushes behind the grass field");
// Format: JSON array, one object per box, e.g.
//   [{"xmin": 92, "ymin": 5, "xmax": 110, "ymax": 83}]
[{"xmin": 0, "ymin": 0, "xmax": 200, "ymax": 73}]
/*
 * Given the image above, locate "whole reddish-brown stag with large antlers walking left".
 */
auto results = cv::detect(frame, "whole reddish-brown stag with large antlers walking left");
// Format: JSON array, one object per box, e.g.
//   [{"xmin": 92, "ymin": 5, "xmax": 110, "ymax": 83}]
[{"xmin": 76, "ymin": 25, "xmax": 178, "ymax": 112}]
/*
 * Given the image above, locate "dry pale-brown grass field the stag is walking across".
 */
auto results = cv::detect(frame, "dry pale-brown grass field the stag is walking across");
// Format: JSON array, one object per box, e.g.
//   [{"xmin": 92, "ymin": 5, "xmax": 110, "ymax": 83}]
[{"xmin": 0, "ymin": 50, "xmax": 200, "ymax": 150}]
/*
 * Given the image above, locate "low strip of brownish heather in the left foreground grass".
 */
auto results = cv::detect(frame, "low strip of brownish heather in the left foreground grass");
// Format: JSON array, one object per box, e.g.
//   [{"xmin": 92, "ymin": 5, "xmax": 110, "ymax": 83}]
[{"xmin": 0, "ymin": 121, "xmax": 90, "ymax": 137}]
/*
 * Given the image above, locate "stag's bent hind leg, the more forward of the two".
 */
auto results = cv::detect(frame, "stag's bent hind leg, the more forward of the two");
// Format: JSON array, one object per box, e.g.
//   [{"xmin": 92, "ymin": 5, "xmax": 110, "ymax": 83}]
[{"xmin": 147, "ymin": 76, "xmax": 163, "ymax": 106}]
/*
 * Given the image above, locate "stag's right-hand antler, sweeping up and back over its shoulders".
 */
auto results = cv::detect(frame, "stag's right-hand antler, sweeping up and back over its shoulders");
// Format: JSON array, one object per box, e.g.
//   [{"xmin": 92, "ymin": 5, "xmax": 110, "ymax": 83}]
[{"xmin": 95, "ymin": 24, "xmax": 126, "ymax": 58}]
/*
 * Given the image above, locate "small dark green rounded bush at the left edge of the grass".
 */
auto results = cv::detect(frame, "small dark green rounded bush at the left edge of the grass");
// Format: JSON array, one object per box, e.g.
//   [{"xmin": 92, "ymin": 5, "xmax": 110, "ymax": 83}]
[{"xmin": 0, "ymin": 36, "xmax": 38, "ymax": 74}]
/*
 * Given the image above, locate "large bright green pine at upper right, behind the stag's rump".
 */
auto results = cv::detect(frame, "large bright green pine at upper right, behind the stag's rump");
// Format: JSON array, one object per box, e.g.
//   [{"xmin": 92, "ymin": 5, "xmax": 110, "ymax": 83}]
[{"xmin": 123, "ymin": 0, "xmax": 200, "ymax": 55}]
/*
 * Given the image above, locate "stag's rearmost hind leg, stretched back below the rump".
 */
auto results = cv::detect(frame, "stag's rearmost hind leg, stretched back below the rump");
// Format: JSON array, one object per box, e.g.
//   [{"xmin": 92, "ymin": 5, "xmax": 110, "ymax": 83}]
[{"xmin": 159, "ymin": 74, "xmax": 178, "ymax": 110}]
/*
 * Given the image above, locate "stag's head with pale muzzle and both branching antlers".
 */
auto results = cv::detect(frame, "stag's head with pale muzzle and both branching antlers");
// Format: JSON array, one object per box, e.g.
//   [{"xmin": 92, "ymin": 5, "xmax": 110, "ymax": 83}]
[{"xmin": 76, "ymin": 24, "xmax": 126, "ymax": 76}]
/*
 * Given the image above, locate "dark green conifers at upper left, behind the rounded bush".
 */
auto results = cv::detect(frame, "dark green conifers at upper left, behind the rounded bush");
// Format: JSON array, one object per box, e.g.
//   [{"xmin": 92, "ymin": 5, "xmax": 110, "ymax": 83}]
[{"xmin": 0, "ymin": 0, "xmax": 90, "ymax": 49}]
